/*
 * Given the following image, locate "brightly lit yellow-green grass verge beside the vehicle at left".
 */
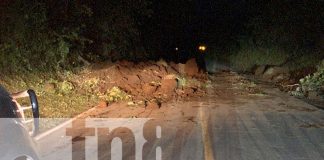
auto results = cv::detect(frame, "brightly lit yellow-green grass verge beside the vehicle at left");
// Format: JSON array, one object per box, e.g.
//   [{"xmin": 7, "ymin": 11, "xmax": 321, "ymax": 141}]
[{"xmin": 0, "ymin": 69, "xmax": 99, "ymax": 118}]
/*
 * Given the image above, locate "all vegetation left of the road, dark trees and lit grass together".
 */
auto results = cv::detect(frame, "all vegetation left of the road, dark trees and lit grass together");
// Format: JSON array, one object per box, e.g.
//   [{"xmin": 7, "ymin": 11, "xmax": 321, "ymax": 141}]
[{"xmin": 0, "ymin": 0, "xmax": 151, "ymax": 117}]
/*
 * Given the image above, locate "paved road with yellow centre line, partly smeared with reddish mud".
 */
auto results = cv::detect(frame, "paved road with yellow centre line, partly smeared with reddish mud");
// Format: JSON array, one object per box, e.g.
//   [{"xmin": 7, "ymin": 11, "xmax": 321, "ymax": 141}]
[{"xmin": 39, "ymin": 73, "xmax": 324, "ymax": 160}]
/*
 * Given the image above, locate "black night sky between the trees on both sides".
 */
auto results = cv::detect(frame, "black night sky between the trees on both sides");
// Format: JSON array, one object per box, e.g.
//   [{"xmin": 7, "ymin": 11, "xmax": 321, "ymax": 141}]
[{"xmin": 144, "ymin": 0, "xmax": 246, "ymax": 52}]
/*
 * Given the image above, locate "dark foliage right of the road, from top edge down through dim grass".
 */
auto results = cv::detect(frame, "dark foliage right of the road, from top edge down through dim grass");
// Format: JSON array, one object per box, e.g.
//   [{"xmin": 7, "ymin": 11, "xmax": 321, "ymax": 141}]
[{"xmin": 229, "ymin": 0, "xmax": 324, "ymax": 71}]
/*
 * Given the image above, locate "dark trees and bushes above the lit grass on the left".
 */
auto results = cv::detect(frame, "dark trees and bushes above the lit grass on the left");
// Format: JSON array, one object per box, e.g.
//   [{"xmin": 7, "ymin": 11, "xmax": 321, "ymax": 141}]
[{"xmin": 0, "ymin": 0, "xmax": 149, "ymax": 73}]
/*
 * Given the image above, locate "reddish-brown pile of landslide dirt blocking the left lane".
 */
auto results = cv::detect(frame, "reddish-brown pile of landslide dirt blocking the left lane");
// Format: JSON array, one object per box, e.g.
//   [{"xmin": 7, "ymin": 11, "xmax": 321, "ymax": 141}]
[{"xmin": 77, "ymin": 59, "xmax": 207, "ymax": 106}]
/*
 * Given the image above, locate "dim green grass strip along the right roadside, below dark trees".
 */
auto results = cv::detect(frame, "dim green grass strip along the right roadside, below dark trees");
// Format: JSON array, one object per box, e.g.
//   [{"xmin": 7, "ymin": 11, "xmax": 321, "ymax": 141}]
[{"xmin": 229, "ymin": 45, "xmax": 323, "ymax": 72}]
